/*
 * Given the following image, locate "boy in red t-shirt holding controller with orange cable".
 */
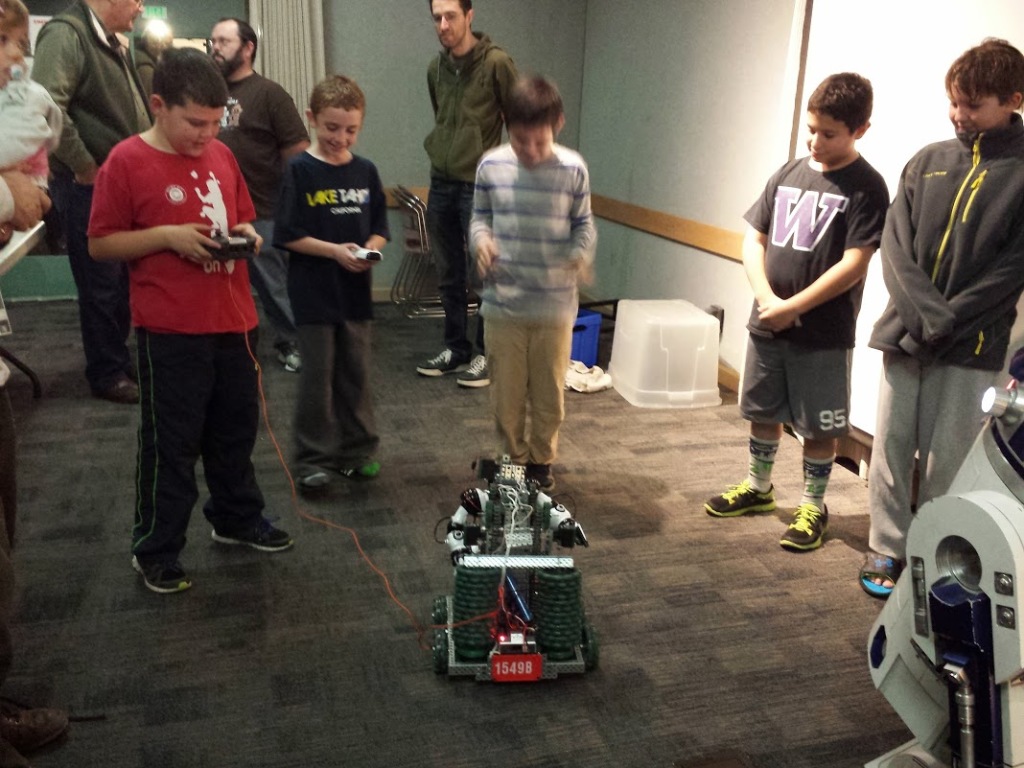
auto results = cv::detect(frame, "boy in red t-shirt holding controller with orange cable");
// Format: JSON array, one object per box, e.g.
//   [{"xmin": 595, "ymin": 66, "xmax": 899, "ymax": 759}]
[{"xmin": 89, "ymin": 49, "xmax": 292, "ymax": 594}]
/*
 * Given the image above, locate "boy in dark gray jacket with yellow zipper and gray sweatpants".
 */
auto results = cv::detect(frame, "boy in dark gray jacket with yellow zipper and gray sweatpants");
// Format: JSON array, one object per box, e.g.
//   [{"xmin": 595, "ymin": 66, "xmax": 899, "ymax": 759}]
[{"xmin": 860, "ymin": 39, "xmax": 1024, "ymax": 598}]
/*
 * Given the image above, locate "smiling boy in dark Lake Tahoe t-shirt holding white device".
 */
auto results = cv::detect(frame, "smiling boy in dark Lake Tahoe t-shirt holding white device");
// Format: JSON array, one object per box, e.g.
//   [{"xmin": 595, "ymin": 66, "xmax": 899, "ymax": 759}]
[{"xmin": 273, "ymin": 75, "xmax": 390, "ymax": 490}]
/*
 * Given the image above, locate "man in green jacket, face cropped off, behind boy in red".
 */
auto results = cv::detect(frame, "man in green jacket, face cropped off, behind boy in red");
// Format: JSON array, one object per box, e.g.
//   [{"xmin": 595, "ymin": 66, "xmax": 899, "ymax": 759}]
[{"xmin": 32, "ymin": 0, "xmax": 152, "ymax": 403}]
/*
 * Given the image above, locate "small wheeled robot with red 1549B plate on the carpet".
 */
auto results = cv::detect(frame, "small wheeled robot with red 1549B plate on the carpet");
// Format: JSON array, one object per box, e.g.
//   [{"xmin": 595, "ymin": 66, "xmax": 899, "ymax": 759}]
[{"xmin": 431, "ymin": 457, "xmax": 598, "ymax": 683}]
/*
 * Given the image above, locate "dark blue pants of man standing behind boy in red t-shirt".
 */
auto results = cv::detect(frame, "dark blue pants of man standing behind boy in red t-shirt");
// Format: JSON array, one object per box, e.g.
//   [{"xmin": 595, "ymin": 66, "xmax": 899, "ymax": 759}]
[{"xmin": 50, "ymin": 170, "xmax": 132, "ymax": 392}]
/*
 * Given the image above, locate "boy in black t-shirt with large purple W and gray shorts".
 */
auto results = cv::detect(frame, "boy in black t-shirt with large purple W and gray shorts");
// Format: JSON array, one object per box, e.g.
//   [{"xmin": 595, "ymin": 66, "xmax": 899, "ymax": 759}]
[{"xmin": 705, "ymin": 73, "xmax": 889, "ymax": 551}]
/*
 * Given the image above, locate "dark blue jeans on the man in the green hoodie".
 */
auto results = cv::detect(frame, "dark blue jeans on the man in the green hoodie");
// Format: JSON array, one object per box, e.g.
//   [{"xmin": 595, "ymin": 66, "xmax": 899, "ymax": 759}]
[{"xmin": 427, "ymin": 178, "xmax": 483, "ymax": 360}]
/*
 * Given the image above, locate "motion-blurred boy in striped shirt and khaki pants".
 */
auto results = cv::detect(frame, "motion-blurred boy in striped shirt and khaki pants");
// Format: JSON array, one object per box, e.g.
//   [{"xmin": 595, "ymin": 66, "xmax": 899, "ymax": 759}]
[{"xmin": 469, "ymin": 77, "xmax": 597, "ymax": 492}]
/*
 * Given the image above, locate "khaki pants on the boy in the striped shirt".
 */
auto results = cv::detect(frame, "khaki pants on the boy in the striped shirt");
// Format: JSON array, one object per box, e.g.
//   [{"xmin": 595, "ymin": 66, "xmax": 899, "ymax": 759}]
[{"xmin": 483, "ymin": 317, "xmax": 572, "ymax": 464}]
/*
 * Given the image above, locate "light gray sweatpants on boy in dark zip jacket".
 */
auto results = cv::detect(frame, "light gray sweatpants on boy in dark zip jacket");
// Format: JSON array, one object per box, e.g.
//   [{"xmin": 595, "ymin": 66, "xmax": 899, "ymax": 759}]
[{"xmin": 867, "ymin": 352, "xmax": 998, "ymax": 560}]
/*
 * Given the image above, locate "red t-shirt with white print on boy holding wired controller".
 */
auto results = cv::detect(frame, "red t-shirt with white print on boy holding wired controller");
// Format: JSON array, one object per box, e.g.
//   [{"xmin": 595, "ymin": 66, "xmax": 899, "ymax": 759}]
[{"xmin": 89, "ymin": 136, "xmax": 257, "ymax": 334}]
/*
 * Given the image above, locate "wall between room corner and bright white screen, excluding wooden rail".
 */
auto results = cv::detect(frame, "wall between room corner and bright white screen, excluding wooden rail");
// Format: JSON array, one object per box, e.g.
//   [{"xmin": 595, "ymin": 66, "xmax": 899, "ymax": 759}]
[{"xmin": 580, "ymin": 0, "xmax": 803, "ymax": 369}]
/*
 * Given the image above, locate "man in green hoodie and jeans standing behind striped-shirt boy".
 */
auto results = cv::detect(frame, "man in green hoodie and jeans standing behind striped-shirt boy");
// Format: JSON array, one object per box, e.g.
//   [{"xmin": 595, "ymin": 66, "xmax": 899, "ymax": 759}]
[{"xmin": 416, "ymin": 0, "xmax": 518, "ymax": 387}]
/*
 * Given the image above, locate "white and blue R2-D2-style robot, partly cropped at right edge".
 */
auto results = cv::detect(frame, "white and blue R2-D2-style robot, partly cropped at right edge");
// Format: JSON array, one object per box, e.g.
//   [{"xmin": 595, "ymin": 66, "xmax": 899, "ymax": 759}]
[{"xmin": 866, "ymin": 381, "xmax": 1024, "ymax": 768}]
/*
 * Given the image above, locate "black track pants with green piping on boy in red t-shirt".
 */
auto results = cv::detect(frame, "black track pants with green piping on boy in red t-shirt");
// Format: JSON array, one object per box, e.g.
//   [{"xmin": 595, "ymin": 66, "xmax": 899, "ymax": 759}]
[{"xmin": 132, "ymin": 329, "xmax": 263, "ymax": 565}]
